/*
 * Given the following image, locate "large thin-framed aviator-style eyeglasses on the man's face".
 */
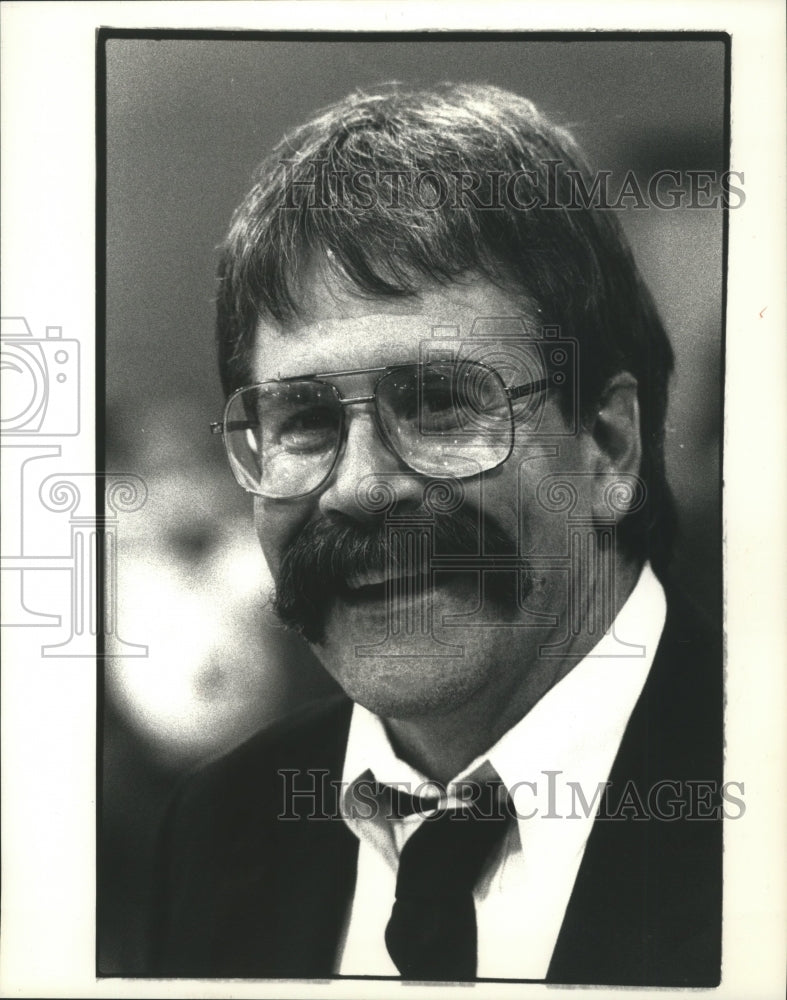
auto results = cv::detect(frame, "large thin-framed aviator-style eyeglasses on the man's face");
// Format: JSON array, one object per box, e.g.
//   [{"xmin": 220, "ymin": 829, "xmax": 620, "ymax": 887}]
[{"xmin": 210, "ymin": 360, "xmax": 548, "ymax": 500}]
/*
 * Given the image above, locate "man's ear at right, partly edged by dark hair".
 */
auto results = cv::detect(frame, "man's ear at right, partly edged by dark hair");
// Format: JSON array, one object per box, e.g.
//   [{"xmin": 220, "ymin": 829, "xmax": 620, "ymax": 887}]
[{"xmin": 589, "ymin": 372, "xmax": 642, "ymax": 518}]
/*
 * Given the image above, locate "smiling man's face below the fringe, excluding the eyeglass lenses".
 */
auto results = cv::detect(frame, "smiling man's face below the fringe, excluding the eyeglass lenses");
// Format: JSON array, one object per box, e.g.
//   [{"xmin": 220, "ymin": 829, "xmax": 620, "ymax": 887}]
[{"xmin": 253, "ymin": 269, "xmax": 588, "ymax": 718}]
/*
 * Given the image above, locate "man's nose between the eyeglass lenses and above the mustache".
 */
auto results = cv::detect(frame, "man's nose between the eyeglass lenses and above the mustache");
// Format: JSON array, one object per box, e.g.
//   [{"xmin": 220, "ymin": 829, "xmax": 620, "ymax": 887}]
[{"xmin": 319, "ymin": 408, "xmax": 423, "ymax": 521}]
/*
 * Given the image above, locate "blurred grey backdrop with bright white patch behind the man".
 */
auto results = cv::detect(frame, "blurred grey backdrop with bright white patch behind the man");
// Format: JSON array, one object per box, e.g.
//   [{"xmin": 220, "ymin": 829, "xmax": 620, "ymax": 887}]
[{"xmin": 99, "ymin": 38, "xmax": 724, "ymax": 975}]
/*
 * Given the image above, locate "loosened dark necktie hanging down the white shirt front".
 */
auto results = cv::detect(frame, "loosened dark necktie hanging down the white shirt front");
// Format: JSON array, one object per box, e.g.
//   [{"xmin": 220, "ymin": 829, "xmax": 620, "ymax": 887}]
[{"xmin": 385, "ymin": 782, "xmax": 508, "ymax": 981}]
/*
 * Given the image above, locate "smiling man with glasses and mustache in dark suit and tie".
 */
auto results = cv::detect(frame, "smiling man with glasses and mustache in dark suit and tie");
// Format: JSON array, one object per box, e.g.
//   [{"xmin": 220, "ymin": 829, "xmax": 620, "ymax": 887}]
[{"xmin": 152, "ymin": 85, "xmax": 722, "ymax": 986}]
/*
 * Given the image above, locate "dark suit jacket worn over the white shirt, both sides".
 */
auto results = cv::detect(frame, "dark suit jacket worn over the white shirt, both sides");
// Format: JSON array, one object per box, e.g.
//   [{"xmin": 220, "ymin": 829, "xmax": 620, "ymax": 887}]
[{"xmin": 151, "ymin": 588, "xmax": 722, "ymax": 987}]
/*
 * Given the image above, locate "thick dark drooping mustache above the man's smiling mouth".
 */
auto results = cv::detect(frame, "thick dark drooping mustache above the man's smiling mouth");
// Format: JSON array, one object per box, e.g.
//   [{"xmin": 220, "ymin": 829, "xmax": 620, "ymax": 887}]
[{"xmin": 273, "ymin": 507, "xmax": 517, "ymax": 644}]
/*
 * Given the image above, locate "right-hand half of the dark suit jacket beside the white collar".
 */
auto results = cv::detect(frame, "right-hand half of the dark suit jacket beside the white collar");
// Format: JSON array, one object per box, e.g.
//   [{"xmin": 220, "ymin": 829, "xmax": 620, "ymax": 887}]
[{"xmin": 547, "ymin": 588, "xmax": 723, "ymax": 986}]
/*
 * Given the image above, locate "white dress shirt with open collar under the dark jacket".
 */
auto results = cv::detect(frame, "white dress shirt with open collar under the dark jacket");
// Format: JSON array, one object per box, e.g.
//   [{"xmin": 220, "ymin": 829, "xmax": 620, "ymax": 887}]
[{"xmin": 335, "ymin": 565, "xmax": 666, "ymax": 979}]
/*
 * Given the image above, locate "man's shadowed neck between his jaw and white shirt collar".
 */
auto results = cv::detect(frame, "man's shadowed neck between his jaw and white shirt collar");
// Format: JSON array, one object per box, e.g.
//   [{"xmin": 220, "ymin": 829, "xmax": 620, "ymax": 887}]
[{"xmin": 384, "ymin": 562, "xmax": 641, "ymax": 784}]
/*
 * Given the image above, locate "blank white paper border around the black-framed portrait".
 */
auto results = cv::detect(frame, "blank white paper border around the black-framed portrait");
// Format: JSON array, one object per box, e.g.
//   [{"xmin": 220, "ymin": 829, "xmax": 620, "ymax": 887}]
[{"xmin": 0, "ymin": 0, "xmax": 787, "ymax": 1000}]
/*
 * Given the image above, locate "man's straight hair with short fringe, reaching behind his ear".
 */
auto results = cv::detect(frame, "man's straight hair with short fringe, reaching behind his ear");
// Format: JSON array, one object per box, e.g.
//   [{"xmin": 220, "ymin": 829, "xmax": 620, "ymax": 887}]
[{"xmin": 217, "ymin": 84, "xmax": 674, "ymax": 569}]
